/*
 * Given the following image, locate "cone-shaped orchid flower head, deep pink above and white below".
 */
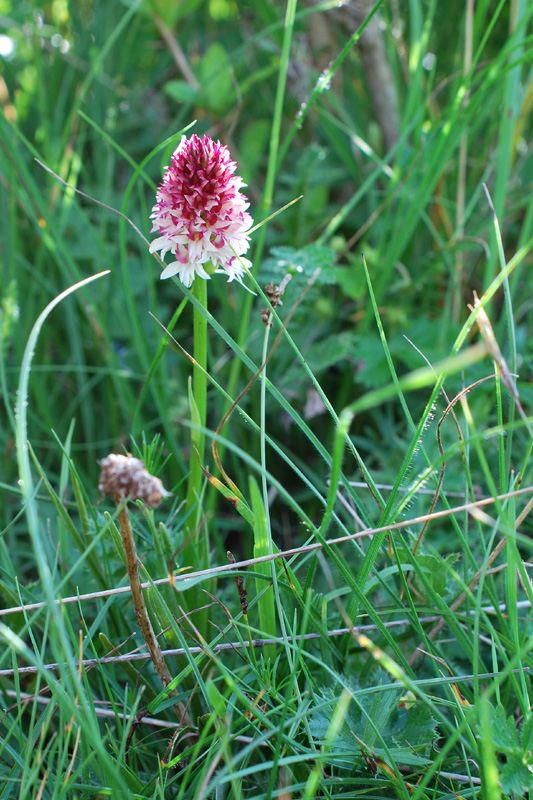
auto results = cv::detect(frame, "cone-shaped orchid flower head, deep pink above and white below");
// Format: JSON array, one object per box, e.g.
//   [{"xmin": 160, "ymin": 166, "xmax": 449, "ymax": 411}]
[{"xmin": 150, "ymin": 134, "xmax": 253, "ymax": 286}]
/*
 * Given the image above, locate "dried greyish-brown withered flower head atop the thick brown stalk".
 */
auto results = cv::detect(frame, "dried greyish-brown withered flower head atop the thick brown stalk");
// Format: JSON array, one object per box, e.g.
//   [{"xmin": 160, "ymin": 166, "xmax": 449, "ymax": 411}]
[{"xmin": 98, "ymin": 453, "xmax": 170, "ymax": 508}]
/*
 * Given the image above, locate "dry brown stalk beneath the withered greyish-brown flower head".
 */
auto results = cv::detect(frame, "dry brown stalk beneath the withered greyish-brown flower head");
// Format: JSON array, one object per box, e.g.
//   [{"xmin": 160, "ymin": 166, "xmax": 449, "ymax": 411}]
[{"xmin": 115, "ymin": 495, "xmax": 191, "ymax": 725}]
